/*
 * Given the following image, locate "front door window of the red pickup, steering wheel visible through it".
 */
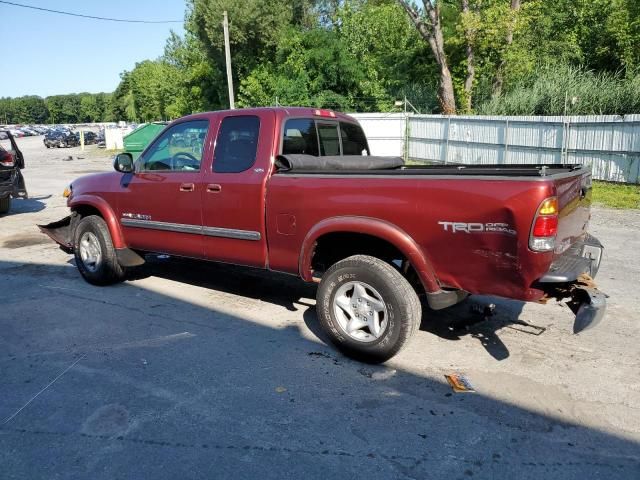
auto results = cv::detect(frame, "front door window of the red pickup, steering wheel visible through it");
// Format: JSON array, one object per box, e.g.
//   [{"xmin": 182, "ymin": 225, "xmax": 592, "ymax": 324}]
[{"xmin": 138, "ymin": 120, "xmax": 209, "ymax": 172}]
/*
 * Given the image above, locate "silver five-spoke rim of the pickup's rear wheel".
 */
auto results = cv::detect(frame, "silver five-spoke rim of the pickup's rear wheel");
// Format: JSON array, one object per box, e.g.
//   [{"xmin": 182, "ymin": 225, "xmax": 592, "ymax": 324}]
[{"xmin": 333, "ymin": 282, "xmax": 389, "ymax": 343}]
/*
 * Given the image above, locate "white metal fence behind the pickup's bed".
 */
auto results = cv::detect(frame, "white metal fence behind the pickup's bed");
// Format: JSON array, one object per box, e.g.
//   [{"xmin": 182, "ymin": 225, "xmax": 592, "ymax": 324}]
[{"xmin": 353, "ymin": 113, "xmax": 640, "ymax": 183}]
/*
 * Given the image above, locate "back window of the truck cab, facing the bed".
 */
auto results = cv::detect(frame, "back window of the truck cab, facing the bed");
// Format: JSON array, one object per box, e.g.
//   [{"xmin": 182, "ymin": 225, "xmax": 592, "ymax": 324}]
[{"xmin": 282, "ymin": 118, "xmax": 370, "ymax": 156}]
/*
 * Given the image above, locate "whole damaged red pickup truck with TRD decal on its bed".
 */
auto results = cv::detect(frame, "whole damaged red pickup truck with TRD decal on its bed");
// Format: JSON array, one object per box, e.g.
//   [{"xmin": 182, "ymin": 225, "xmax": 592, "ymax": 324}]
[{"xmin": 41, "ymin": 108, "xmax": 605, "ymax": 361}]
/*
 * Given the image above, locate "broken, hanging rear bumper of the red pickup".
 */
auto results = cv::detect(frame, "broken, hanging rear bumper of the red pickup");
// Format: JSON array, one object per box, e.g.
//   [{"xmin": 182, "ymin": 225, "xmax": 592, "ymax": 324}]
[{"xmin": 536, "ymin": 234, "xmax": 607, "ymax": 333}]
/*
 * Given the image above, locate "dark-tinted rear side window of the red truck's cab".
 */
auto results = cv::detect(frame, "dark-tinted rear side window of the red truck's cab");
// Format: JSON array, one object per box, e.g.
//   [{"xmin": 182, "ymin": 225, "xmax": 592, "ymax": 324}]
[{"xmin": 213, "ymin": 115, "xmax": 260, "ymax": 173}]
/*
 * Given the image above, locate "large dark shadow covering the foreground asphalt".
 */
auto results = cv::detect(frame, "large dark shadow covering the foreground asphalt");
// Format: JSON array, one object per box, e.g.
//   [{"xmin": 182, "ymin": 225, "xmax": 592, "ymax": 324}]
[{"xmin": 0, "ymin": 261, "xmax": 640, "ymax": 480}]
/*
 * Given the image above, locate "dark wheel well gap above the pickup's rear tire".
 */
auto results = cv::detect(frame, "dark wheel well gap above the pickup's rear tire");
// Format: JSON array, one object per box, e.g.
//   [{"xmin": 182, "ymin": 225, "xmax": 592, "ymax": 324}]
[{"xmin": 311, "ymin": 232, "xmax": 422, "ymax": 288}]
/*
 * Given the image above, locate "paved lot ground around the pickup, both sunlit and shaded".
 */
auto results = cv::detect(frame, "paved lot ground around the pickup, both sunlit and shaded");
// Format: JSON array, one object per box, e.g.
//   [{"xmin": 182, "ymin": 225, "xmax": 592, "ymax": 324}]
[{"xmin": 0, "ymin": 137, "xmax": 640, "ymax": 480}]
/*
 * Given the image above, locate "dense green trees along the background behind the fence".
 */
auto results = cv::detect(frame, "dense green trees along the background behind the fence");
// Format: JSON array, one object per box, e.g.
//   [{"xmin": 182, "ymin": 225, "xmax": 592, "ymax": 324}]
[{"xmin": 0, "ymin": 0, "xmax": 640, "ymax": 123}]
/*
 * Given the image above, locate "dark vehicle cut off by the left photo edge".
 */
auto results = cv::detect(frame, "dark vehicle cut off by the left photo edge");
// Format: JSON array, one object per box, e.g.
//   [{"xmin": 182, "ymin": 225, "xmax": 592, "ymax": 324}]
[{"xmin": 0, "ymin": 131, "xmax": 27, "ymax": 215}]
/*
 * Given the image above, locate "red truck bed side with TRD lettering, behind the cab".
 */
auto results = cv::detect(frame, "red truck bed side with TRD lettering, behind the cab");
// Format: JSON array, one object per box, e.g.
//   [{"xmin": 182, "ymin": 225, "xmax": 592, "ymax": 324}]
[{"xmin": 267, "ymin": 161, "xmax": 591, "ymax": 301}]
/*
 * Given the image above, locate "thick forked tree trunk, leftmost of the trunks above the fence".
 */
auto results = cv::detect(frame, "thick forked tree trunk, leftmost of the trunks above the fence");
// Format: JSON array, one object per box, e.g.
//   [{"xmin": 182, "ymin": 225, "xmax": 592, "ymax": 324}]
[{"xmin": 398, "ymin": 0, "xmax": 456, "ymax": 115}]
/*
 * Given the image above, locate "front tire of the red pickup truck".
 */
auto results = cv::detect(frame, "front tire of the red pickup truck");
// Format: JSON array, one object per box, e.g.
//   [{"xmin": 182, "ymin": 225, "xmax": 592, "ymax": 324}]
[{"xmin": 73, "ymin": 215, "xmax": 126, "ymax": 285}]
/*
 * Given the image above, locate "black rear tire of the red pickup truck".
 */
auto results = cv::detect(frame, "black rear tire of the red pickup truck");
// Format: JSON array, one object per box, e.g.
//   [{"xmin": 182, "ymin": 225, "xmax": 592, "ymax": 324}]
[{"xmin": 316, "ymin": 255, "xmax": 422, "ymax": 363}]
